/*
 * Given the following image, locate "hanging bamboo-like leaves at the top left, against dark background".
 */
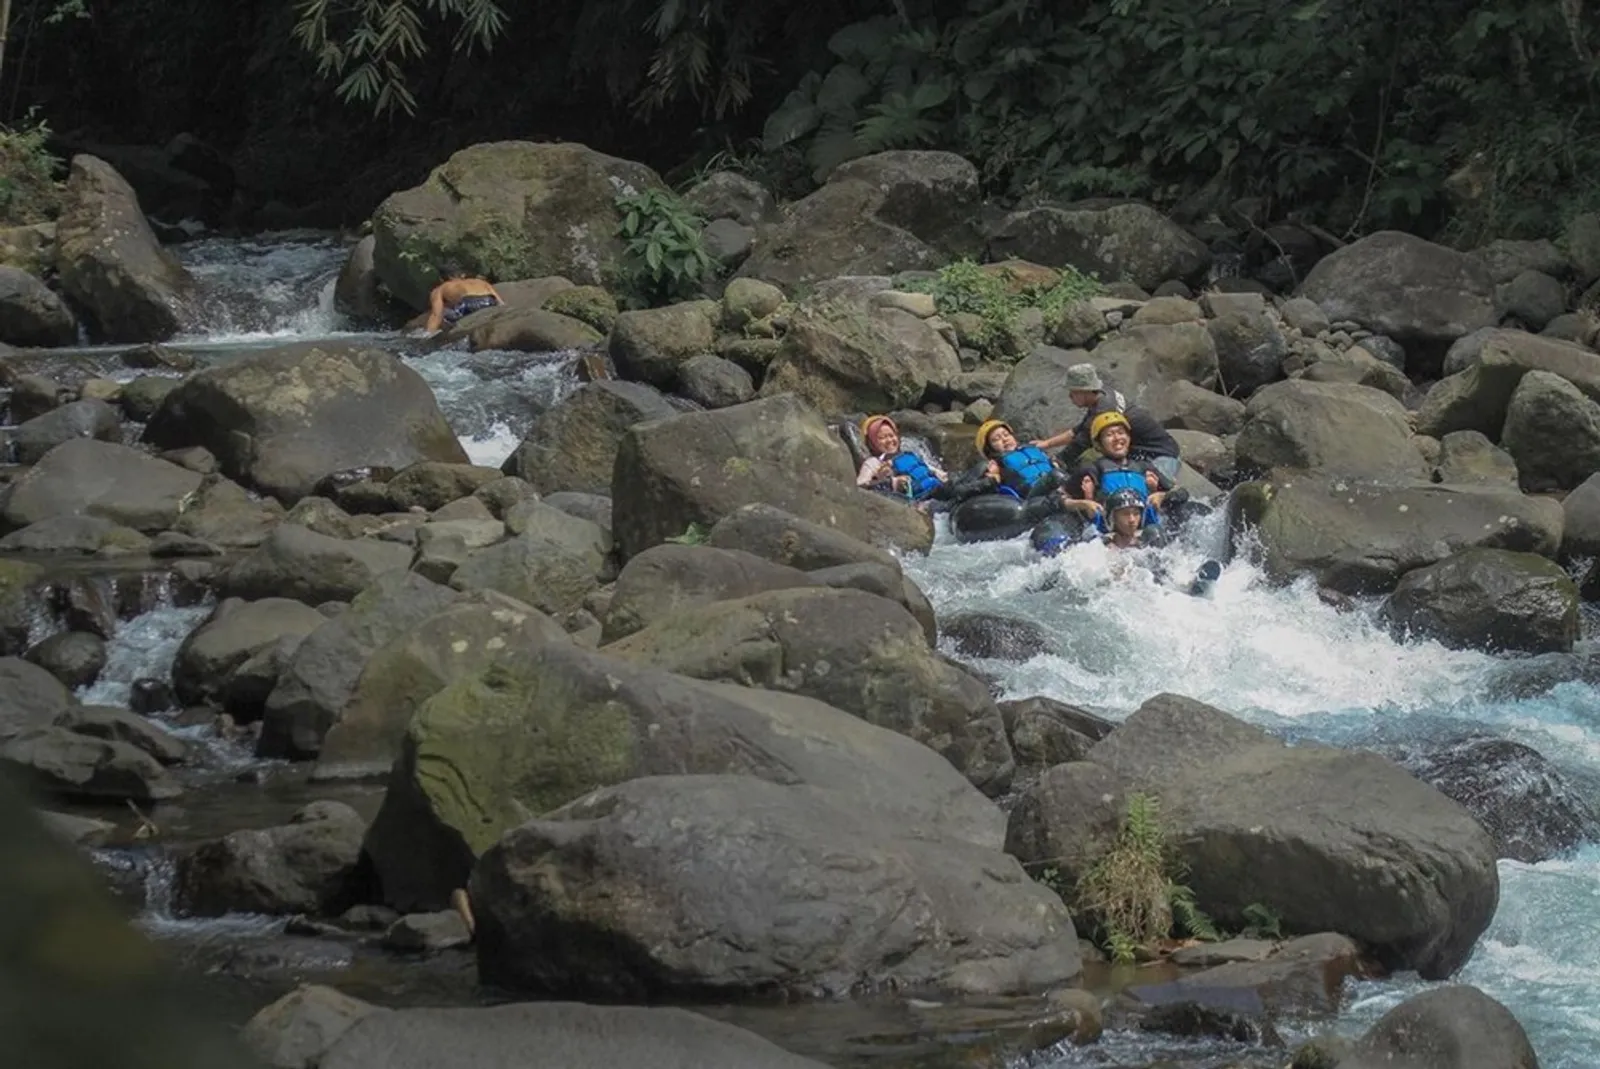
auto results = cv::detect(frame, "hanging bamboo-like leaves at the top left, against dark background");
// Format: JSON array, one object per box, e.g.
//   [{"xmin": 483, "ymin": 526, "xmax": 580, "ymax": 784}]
[{"xmin": 294, "ymin": 0, "xmax": 506, "ymax": 115}]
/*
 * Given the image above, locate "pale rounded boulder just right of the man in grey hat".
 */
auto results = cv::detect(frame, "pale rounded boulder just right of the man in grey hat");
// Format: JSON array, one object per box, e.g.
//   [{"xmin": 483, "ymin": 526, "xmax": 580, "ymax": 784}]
[{"xmin": 1234, "ymin": 379, "xmax": 1430, "ymax": 478}]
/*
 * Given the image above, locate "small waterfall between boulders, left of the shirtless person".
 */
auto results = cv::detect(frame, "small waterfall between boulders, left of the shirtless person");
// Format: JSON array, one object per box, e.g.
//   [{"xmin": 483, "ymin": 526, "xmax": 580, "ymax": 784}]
[{"xmin": 173, "ymin": 232, "xmax": 360, "ymax": 342}]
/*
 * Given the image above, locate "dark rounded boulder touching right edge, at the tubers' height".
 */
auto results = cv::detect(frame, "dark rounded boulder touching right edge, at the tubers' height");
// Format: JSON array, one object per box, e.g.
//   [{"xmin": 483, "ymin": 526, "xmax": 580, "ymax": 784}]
[{"xmin": 1501, "ymin": 363, "xmax": 1600, "ymax": 493}]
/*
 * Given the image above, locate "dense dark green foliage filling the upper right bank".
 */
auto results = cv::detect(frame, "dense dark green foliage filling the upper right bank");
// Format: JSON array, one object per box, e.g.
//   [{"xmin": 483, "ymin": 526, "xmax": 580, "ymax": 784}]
[{"xmin": 763, "ymin": 0, "xmax": 1600, "ymax": 240}]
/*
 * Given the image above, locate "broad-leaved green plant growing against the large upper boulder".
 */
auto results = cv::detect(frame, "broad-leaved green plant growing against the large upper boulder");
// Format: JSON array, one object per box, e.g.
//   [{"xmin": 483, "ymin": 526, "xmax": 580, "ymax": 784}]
[{"xmin": 616, "ymin": 189, "xmax": 717, "ymax": 307}]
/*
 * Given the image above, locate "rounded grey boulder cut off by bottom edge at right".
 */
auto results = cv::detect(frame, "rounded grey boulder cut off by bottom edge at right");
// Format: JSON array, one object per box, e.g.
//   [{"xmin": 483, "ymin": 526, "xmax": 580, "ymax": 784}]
[{"xmin": 1338, "ymin": 984, "xmax": 1539, "ymax": 1069}]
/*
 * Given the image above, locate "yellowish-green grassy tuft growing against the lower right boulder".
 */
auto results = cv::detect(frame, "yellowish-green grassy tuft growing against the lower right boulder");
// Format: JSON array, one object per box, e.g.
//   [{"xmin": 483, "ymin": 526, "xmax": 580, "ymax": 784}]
[{"xmin": 1074, "ymin": 794, "xmax": 1218, "ymax": 963}]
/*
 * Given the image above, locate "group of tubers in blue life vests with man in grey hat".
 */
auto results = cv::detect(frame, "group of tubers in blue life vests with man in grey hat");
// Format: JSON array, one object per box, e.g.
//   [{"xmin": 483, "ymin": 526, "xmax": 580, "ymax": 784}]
[{"xmin": 856, "ymin": 363, "xmax": 1216, "ymax": 579}]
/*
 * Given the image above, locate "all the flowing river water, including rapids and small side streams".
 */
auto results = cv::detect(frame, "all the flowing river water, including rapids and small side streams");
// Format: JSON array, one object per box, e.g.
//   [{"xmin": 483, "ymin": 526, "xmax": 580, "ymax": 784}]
[{"xmin": 25, "ymin": 234, "xmax": 1600, "ymax": 1069}]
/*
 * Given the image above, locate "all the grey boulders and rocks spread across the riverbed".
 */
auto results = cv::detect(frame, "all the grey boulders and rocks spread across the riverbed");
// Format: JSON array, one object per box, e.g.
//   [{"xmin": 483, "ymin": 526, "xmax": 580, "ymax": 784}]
[{"xmin": 0, "ymin": 142, "xmax": 1574, "ymax": 1069}]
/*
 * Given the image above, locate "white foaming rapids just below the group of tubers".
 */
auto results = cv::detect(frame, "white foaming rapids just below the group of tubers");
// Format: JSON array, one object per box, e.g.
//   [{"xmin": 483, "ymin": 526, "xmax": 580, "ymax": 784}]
[{"xmin": 906, "ymin": 512, "xmax": 1494, "ymax": 722}]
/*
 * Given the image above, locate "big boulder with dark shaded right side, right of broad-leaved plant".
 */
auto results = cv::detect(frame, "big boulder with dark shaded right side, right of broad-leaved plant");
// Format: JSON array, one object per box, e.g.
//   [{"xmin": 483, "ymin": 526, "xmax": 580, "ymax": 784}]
[{"xmin": 738, "ymin": 150, "xmax": 982, "ymax": 291}]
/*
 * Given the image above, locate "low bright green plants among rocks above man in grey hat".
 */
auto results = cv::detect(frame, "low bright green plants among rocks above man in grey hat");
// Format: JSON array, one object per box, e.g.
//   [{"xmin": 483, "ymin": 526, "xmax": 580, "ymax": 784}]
[{"xmin": 904, "ymin": 259, "xmax": 1104, "ymax": 360}]
